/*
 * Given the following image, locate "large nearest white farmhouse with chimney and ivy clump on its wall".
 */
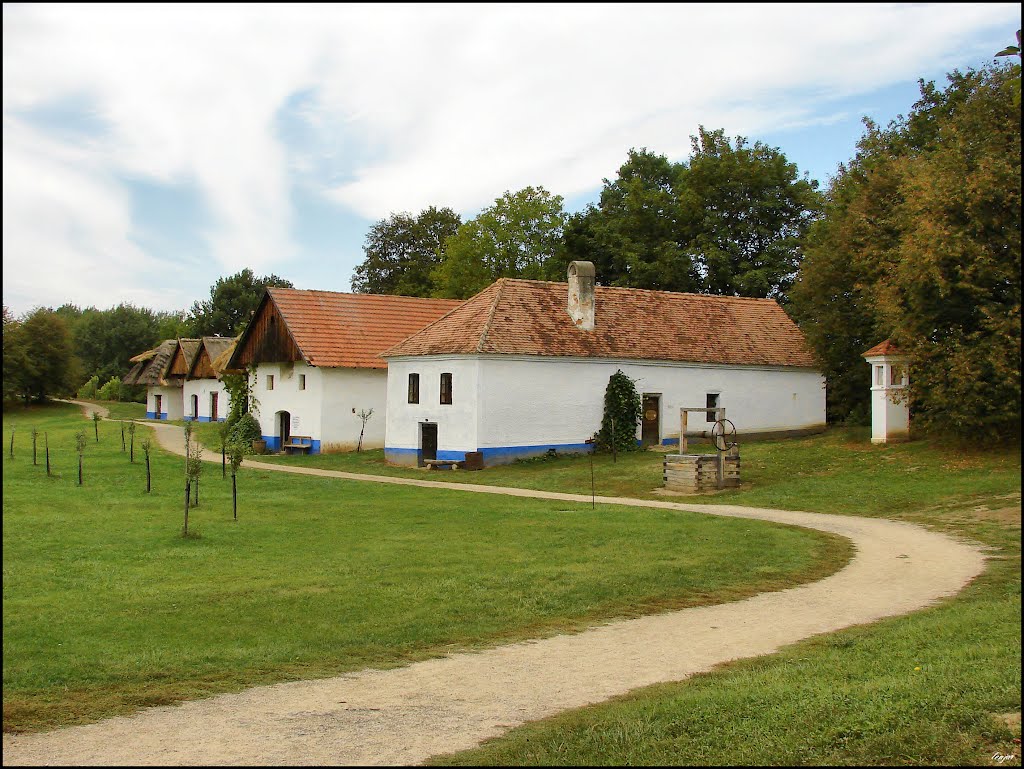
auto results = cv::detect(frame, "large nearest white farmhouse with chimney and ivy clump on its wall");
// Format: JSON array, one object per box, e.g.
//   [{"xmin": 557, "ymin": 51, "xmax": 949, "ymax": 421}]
[{"xmin": 384, "ymin": 262, "xmax": 825, "ymax": 465}]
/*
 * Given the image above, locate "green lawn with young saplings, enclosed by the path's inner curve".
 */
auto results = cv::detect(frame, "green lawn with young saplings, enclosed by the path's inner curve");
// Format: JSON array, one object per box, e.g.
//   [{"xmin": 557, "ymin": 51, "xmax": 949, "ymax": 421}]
[{"xmin": 3, "ymin": 404, "xmax": 850, "ymax": 731}]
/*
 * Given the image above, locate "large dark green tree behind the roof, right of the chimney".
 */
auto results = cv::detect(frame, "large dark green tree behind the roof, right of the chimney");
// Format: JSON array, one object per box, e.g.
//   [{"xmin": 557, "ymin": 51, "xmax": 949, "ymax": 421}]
[{"xmin": 559, "ymin": 137, "xmax": 821, "ymax": 299}]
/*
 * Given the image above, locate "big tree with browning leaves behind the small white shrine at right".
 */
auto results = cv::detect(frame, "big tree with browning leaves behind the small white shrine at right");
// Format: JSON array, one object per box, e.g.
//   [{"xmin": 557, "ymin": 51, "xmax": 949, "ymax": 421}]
[{"xmin": 793, "ymin": 65, "xmax": 1021, "ymax": 437}]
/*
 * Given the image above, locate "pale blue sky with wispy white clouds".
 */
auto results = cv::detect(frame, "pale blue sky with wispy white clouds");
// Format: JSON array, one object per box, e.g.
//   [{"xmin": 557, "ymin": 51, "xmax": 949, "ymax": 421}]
[{"xmin": 3, "ymin": 3, "xmax": 1021, "ymax": 315}]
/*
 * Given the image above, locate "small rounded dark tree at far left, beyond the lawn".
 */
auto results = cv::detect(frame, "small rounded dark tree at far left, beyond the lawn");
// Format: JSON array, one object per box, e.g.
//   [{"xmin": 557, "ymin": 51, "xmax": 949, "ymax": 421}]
[{"xmin": 22, "ymin": 307, "xmax": 75, "ymax": 400}]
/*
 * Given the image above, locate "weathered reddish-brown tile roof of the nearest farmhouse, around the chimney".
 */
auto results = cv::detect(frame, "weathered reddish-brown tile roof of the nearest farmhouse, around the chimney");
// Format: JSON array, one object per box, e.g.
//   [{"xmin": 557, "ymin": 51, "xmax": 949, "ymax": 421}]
[{"xmin": 384, "ymin": 279, "xmax": 816, "ymax": 368}]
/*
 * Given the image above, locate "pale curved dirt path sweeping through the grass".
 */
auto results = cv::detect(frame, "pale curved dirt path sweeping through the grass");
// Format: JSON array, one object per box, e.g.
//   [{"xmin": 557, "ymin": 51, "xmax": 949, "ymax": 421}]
[{"xmin": 3, "ymin": 423, "xmax": 984, "ymax": 765}]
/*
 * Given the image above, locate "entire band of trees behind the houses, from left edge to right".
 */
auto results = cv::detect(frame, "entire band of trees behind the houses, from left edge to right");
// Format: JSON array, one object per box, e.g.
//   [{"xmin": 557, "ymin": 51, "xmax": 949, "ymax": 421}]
[{"xmin": 3, "ymin": 48, "xmax": 1021, "ymax": 438}]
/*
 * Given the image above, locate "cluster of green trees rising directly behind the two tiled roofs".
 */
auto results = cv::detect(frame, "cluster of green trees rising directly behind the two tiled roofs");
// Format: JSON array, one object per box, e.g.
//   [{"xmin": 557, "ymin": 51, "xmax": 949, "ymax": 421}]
[{"xmin": 352, "ymin": 126, "xmax": 823, "ymax": 299}]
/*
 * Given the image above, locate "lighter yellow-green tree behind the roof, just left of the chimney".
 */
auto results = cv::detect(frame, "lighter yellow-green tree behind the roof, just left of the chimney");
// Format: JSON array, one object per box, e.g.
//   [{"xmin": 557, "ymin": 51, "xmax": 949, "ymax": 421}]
[{"xmin": 431, "ymin": 186, "xmax": 566, "ymax": 299}]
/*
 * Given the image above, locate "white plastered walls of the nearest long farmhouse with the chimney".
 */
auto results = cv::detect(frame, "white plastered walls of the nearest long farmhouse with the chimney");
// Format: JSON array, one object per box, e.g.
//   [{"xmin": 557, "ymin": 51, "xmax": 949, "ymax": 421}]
[{"xmin": 387, "ymin": 355, "xmax": 825, "ymax": 456}]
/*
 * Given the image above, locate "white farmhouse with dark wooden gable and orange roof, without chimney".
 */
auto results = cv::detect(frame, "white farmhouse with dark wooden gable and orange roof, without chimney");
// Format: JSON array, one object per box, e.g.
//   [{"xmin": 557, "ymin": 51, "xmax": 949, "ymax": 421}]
[{"xmin": 230, "ymin": 288, "xmax": 462, "ymax": 454}]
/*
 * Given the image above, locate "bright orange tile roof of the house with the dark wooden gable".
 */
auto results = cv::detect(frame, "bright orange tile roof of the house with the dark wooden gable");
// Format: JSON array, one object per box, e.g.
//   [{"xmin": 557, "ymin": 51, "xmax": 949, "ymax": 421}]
[{"xmin": 267, "ymin": 288, "xmax": 462, "ymax": 369}]
